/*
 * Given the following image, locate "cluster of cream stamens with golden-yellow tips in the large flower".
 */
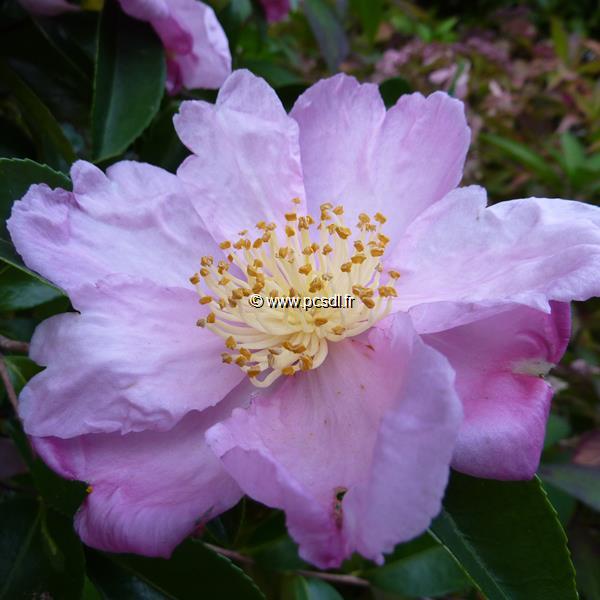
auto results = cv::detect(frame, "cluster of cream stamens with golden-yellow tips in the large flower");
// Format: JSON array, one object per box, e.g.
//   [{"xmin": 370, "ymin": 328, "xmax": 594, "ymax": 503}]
[{"xmin": 190, "ymin": 198, "xmax": 400, "ymax": 387}]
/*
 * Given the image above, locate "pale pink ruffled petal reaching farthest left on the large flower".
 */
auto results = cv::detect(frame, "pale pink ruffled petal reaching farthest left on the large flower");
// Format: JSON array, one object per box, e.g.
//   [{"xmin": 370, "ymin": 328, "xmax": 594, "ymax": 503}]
[{"xmin": 7, "ymin": 161, "xmax": 221, "ymax": 298}]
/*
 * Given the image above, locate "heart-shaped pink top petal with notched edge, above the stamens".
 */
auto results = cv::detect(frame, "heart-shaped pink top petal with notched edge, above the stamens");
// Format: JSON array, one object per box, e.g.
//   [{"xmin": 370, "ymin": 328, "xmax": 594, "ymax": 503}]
[{"xmin": 290, "ymin": 74, "xmax": 470, "ymax": 242}]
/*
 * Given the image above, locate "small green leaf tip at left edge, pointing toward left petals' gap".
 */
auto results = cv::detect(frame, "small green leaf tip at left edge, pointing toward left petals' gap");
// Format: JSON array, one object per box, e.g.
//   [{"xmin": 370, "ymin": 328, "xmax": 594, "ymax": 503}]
[{"xmin": 0, "ymin": 265, "xmax": 62, "ymax": 312}]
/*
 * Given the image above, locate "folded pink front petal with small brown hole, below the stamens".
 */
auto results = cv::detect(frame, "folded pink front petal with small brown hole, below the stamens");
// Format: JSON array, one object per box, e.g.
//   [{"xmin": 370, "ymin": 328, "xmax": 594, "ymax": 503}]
[{"xmin": 207, "ymin": 315, "xmax": 461, "ymax": 568}]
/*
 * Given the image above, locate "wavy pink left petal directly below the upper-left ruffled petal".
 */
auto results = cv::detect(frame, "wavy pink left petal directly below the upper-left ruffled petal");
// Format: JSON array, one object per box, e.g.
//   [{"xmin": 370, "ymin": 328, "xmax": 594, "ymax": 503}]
[{"xmin": 20, "ymin": 277, "xmax": 243, "ymax": 437}]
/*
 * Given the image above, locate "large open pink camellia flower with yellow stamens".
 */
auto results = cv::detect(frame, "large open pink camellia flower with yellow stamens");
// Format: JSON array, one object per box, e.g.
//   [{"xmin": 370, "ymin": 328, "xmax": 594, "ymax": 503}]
[{"xmin": 8, "ymin": 71, "xmax": 600, "ymax": 568}]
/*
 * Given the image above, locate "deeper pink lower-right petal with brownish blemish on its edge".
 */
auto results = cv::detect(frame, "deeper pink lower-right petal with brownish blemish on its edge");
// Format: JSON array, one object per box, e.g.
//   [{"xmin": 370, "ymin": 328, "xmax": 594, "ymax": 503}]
[{"xmin": 423, "ymin": 302, "xmax": 570, "ymax": 479}]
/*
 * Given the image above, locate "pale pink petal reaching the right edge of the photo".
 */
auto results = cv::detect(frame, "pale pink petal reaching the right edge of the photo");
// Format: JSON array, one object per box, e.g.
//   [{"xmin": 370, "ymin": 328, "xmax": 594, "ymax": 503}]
[{"xmin": 386, "ymin": 186, "xmax": 600, "ymax": 333}]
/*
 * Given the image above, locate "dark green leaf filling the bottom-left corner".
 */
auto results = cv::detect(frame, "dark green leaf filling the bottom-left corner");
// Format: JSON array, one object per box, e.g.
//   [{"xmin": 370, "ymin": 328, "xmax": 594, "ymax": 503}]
[{"xmin": 0, "ymin": 496, "xmax": 84, "ymax": 600}]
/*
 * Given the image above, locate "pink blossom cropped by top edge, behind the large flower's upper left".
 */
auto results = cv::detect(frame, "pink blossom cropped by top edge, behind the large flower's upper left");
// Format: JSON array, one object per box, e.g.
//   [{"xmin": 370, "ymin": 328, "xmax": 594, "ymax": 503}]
[{"xmin": 20, "ymin": 0, "xmax": 231, "ymax": 93}]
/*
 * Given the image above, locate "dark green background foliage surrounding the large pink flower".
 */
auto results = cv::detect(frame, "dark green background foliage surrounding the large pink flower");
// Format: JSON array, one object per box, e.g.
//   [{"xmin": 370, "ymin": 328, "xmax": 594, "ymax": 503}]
[{"xmin": 0, "ymin": 0, "xmax": 600, "ymax": 600}]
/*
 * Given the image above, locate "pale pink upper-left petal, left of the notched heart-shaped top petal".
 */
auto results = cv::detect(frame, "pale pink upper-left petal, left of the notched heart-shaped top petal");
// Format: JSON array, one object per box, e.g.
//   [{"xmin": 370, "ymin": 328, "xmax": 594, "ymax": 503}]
[{"xmin": 174, "ymin": 70, "xmax": 304, "ymax": 241}]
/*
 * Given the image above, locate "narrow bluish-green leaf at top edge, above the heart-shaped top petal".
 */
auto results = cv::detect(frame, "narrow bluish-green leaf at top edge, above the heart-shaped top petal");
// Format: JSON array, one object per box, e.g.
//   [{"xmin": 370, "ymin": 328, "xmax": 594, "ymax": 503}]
[{"xmin": 304, "ymin": 0, "xmax": 349, "ymax": 71}]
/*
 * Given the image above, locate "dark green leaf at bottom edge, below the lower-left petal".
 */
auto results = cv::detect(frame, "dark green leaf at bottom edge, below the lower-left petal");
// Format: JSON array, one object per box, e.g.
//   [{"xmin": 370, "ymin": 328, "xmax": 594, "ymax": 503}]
[{"xmin": 105, "ymin": 540, "xmax": 264, "ymax": 600}]
